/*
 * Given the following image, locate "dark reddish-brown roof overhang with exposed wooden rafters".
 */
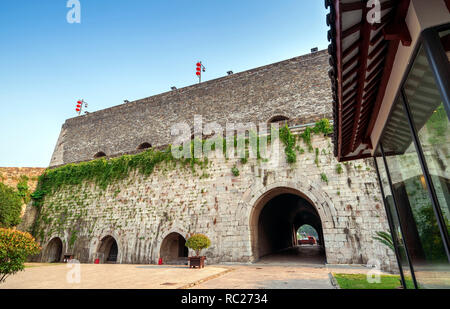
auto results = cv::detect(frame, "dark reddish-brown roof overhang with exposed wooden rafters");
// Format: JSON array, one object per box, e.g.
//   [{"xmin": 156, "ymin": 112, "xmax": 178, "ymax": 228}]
[{"xmin": 325, "ymin": 0, "xmax": 411, "ymax": 161}]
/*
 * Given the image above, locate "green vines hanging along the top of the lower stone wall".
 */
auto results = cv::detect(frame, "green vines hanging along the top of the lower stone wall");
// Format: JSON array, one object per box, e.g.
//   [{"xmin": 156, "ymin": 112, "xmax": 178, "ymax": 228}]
[{"xmin": 31, "ymin": 119, "xmax": 332, "ymax": 239}]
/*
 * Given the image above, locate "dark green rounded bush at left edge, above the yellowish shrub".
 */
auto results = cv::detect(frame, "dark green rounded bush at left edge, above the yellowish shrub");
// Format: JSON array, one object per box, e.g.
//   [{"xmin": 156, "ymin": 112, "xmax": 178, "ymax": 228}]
[{"xmin": 0, "ymin": 182, "xmax": 23, "ymax": 227}]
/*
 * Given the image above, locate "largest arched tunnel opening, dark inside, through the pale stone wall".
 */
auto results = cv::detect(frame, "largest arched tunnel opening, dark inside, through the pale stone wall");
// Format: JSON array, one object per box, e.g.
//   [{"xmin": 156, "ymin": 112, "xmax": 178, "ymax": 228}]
[{"xmin": 250, "ymin": 187, "xmax": 326, "ymax": 264}]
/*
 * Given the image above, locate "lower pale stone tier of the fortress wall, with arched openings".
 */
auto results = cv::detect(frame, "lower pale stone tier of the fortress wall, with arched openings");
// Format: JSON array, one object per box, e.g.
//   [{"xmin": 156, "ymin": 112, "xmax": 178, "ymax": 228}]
[{"xmin": 34, "ymin": 132, "xmax": 395, "ymax": 270}]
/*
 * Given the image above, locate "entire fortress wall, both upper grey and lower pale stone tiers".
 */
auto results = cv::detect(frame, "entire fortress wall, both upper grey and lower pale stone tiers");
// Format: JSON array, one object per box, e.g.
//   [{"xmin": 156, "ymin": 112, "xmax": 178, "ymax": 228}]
[{"xmin": 22, "ymin": 51, "xmax": 395, "ymax": 270}]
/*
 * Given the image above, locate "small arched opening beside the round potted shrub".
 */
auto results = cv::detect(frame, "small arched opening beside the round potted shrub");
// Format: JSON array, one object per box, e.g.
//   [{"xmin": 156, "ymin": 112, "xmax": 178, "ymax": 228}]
[{"xmin": 159, "ymin": 232, "xmax": 189, "ymax": 264}]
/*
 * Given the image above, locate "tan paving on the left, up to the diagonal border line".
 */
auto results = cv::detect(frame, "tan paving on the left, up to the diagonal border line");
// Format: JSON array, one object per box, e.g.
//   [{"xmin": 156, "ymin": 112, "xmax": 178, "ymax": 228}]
[{"xmin": 0, "ymin": 263, "xmax": 228, "ymax": 289}]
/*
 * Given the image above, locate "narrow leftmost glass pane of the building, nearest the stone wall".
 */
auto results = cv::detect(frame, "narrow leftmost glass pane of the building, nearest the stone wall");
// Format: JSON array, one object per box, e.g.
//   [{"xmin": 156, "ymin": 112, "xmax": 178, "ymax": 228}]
[{"xmin": 376, "ymin": 151, "xmax": 415, "ymax": 289}]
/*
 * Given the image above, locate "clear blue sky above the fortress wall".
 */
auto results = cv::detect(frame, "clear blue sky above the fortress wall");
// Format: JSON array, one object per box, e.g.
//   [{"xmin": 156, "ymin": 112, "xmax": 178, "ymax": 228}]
[{"xmin": 0, "ymin": 0, "xmax": 328, "ymax": 167}]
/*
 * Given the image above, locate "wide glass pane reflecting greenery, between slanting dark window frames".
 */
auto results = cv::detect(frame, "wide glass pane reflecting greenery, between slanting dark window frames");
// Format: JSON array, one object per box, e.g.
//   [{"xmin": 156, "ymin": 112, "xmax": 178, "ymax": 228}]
[{"xmin": 381, "ymin": 98, "xmax": 450, "ymax": 288}]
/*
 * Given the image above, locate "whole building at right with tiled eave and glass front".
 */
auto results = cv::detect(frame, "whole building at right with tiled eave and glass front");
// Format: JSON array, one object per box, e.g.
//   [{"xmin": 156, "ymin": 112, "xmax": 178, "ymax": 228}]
[{"xmin": 325, "ymin": 0, "xmax": 450, "ymax": 288}]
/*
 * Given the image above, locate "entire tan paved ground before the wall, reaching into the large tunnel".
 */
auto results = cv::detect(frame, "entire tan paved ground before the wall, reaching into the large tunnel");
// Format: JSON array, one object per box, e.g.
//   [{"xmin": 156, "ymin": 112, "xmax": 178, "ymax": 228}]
[{"xmin": 0, "ymin": 246, "xmax": 388, "ymax": 289}]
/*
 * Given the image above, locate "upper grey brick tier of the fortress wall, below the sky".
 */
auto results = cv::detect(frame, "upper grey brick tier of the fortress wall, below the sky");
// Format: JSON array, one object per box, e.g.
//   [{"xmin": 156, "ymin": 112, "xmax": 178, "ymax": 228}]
[{"xmin": 50, "ymin": 51, "xmax": 332, "ymax": 166}]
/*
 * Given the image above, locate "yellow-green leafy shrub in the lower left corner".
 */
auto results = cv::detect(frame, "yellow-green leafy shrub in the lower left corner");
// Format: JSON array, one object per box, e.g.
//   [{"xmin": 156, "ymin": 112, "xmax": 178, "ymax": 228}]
[{"xmin": 0, "ymin": 228, "xmax": 41, "ymax": 283}]
